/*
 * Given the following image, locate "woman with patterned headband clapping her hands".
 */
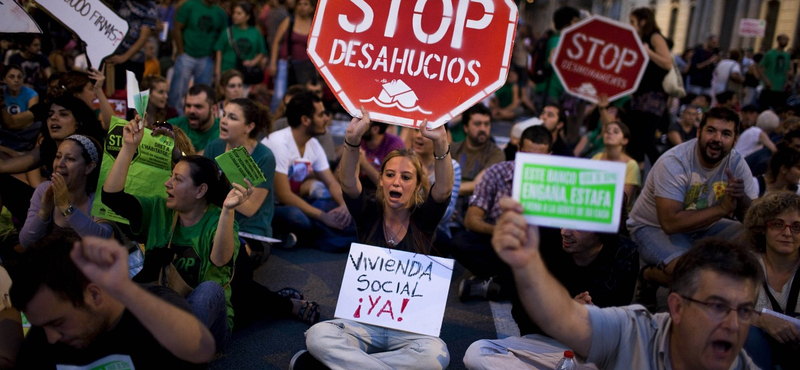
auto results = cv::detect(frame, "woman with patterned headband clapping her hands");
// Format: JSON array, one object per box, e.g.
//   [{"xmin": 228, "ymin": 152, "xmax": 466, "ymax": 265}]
[{"xmin": 19, "ymin": 135, "xmax": 112, "ymax": 247}]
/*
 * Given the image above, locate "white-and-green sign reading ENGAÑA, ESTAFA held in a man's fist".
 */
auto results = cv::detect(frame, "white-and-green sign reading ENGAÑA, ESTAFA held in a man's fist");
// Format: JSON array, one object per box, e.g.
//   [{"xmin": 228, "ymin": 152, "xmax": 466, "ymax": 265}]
[{"xmin": 512, "ymin": 153, "xmax": 625, "ymax": 232}]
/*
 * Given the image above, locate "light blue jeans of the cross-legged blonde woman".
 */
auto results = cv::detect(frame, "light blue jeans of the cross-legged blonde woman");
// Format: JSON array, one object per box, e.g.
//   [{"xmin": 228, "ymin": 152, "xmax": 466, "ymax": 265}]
[{"xmin": 306, "ymin": 319, "xmax": 450, "ymax": 370}]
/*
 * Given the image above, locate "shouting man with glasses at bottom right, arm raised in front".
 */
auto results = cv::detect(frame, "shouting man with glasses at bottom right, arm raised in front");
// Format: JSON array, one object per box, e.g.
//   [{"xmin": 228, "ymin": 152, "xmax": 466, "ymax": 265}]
[{"xmin": 476, "ymin": 198, "xmax": 762, "ymax": 370}]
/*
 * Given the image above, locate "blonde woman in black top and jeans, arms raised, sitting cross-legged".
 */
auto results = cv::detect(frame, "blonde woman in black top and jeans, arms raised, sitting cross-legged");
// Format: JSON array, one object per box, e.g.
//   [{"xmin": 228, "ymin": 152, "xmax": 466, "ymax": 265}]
[{"xmin": 291, "ymin": 108, "xmax": 453, "ymax": 369}]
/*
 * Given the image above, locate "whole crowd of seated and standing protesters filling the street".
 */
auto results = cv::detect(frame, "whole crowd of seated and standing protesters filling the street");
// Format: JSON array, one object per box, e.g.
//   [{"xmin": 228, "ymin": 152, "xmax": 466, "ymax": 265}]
[{"xmin": 0, "ymin": 0, "xmax": 800, "ymax": 369}]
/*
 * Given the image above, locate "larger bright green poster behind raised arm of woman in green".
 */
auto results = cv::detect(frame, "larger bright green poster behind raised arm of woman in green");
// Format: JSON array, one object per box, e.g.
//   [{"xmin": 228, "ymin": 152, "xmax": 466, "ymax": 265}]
[{"xmin": 92, "ymin": 116, "xmax": 175, "ymax": 224}]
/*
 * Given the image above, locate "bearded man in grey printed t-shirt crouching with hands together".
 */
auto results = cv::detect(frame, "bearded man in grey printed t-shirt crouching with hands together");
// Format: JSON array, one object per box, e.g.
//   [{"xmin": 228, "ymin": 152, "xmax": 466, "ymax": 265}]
[{"xmin": 628, "ymin": 108, "xmax": 758, "ymax": 300}]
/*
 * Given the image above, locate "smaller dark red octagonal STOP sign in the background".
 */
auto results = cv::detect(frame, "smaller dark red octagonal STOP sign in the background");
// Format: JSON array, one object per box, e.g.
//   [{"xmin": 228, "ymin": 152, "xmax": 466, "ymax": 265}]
[{"xmin": 553, "ymin": 16, "xmax": 649, "ymax": 103}]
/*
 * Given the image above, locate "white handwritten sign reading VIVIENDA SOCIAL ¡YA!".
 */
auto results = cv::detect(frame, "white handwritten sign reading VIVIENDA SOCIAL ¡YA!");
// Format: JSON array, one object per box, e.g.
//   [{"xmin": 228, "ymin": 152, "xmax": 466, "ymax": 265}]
[{"xmin": 334, "ymin": 243, "xmax": 453, "ymax": 337}]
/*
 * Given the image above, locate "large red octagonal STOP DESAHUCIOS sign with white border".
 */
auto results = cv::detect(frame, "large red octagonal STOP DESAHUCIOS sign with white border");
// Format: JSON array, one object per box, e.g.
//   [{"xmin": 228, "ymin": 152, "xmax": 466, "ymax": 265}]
[{"xmin": 308, "ymin": 0, "xmax": 517, "ymax": 127}]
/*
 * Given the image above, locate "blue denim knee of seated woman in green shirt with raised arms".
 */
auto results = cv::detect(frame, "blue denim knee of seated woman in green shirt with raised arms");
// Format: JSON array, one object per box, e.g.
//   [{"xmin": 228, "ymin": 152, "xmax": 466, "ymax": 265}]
[{"xmin": 186, "ymin": 281, "xmax": 231, "ymax": 352}]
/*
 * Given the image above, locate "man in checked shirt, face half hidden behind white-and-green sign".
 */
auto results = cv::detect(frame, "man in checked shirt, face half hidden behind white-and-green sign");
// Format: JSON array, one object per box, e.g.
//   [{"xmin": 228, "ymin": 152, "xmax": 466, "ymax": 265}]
[{"xmin": 451, "ymin": 125, "xmax": 551, "ymax": 300}]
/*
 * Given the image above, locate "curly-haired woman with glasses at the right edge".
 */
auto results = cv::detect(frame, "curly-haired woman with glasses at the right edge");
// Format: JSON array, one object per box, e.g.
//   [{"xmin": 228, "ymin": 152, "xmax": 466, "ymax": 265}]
[{"xmin": 744, "ymin": 191, "xmax": 800, "ymax": 369}]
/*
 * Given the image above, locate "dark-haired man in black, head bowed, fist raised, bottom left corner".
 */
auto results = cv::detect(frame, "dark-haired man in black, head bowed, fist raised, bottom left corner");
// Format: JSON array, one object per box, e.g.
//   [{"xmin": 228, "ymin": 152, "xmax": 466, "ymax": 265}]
[{"xmin": 11, "ymin": 233, "xmax": 215, "ymax": 369}]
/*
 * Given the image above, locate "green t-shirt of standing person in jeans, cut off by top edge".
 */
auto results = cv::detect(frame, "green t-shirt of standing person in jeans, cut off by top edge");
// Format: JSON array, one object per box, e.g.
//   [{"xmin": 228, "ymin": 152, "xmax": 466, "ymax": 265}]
[{"xmin": 175, "ymin": 0, "xmax": 228, "ymax": 58}]
